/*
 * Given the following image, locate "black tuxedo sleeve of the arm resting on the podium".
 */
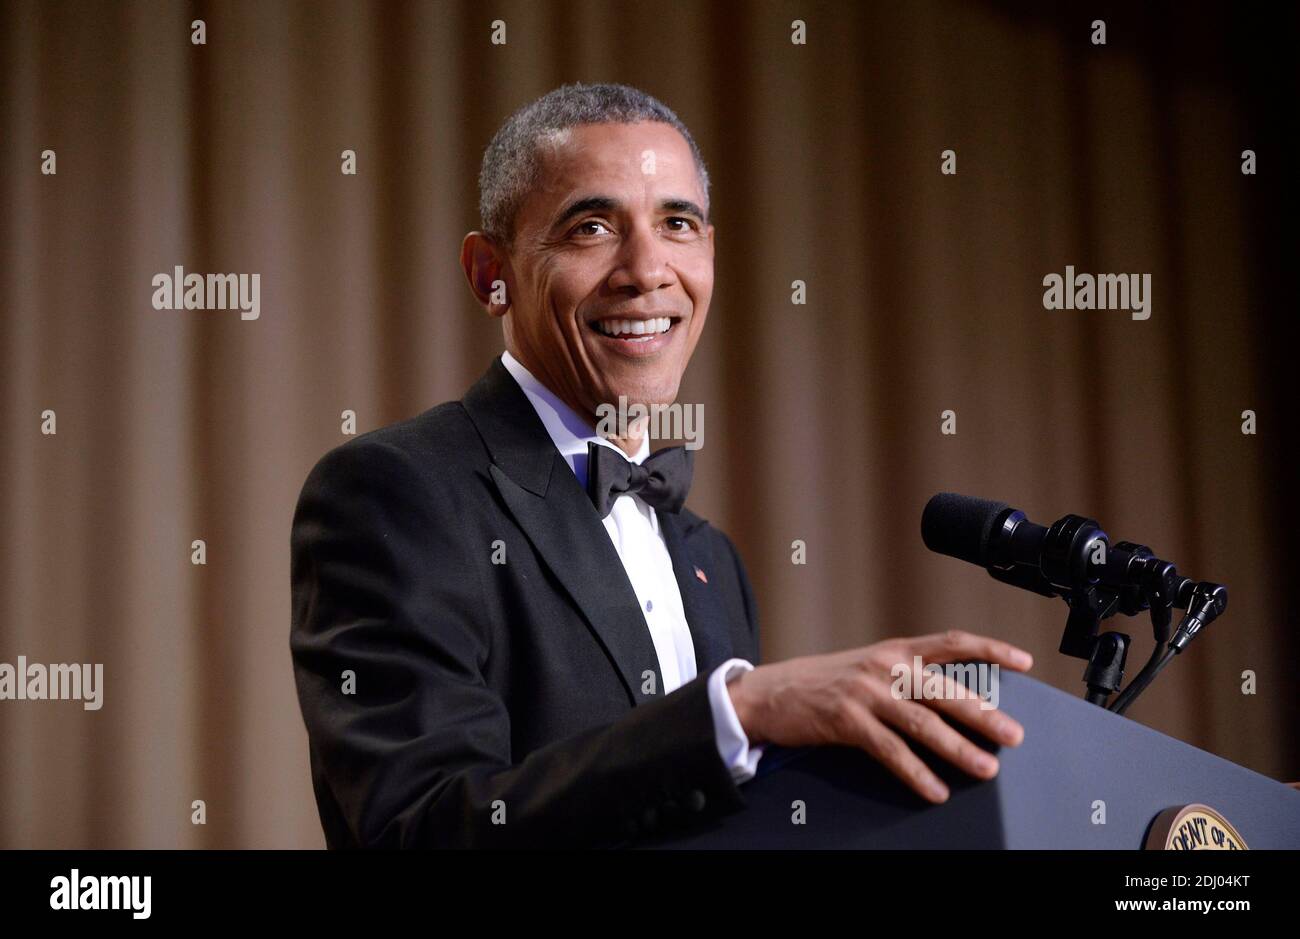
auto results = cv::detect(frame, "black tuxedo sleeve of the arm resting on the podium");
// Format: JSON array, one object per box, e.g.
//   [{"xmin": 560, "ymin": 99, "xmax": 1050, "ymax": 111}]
[{"xmin": 290, "ymin": 438, "xmax": 745, "ymax": 847}]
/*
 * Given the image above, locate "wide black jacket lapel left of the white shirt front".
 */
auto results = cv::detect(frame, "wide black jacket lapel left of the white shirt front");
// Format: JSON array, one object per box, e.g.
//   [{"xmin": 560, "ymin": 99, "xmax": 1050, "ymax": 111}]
[{"xmin": 462, "ymin": 356, "xmax": 665, "ymax": 704}]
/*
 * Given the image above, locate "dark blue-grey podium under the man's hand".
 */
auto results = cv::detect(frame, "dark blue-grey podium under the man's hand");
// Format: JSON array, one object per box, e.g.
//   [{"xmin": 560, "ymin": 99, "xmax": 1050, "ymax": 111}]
[{"xmin": 655, "ymin": 670, "xmax": 1300, "ymax": 849}]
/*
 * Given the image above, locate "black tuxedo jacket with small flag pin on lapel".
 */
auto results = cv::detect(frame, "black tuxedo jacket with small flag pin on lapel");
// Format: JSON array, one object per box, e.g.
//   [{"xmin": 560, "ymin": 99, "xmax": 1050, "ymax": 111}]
[{"xmin": 290, "ymin": 358, "xmax": 758, "ymax": 848}]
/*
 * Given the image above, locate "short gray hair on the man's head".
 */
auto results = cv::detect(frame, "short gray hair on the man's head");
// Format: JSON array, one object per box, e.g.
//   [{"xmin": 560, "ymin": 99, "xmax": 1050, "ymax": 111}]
[{"xmin": 478, "ymin": 83, "xmax": 709, "ymax": 247}]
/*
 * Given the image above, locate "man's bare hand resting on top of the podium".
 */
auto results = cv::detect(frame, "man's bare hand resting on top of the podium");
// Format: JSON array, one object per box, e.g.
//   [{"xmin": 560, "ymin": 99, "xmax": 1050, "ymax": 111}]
[{"xmin": 727, "ymin": 629, "xmax": 1034, "ymax": 802}]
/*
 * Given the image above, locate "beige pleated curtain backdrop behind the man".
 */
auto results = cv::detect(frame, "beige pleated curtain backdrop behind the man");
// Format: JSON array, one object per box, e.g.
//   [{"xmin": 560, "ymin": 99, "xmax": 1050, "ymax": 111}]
[{"xmin": 0, "ymin": 0, "xmax": 1300, "ymax": 848}]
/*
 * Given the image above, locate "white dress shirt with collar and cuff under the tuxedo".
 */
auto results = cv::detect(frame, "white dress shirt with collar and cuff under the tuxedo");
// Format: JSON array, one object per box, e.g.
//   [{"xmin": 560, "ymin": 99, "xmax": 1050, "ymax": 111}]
[{"xmin": 501, "ymin": 352, "xmax": 763, "ymax": 783}]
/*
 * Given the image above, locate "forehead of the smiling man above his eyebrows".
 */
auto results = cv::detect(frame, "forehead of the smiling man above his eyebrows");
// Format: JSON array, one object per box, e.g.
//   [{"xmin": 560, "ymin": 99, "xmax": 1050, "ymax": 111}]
[{"xmin": 525, "ymin": 121, "xmax": 703, "ymax": 204}]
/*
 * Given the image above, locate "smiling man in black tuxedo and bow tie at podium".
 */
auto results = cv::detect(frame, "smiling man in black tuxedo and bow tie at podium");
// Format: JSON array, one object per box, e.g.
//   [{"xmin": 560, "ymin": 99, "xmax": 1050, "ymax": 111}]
[{"xmin": 291, "ymin": 85, "xmax": 1031, "ymax": 847}]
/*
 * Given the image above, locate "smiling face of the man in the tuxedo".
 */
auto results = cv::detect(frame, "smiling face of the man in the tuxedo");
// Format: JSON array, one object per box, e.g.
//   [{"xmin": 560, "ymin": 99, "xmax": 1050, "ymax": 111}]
[{"xmin": 488, "ymin": 122, "xmax": 714, "ymax": 417}]
